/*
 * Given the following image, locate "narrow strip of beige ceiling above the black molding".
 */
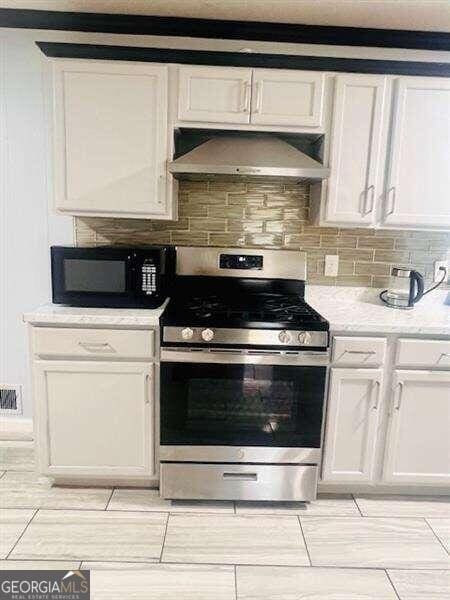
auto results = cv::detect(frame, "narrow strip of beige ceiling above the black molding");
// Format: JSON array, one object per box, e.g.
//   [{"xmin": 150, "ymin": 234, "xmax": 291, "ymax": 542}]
[{"xmin": 0, "ymin": 0, "xmax": 450, "ymax": 32}]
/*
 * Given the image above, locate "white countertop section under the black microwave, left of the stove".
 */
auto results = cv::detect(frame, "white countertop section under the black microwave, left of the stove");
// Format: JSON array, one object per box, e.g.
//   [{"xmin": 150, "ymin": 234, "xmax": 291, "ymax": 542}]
[{"xmin": 23, "ymin": 302, "xmax": 167, "ymax": 328}]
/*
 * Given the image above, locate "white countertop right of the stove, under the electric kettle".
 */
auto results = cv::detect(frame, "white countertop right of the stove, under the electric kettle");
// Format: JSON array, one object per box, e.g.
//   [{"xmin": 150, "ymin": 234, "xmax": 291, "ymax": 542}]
[{"xmin": 306, "ymin": 285, "xmax": 450, "ymax": 335}]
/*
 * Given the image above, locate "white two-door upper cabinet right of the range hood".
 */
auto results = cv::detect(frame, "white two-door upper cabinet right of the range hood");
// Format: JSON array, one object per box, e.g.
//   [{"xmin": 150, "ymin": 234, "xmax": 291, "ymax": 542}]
[{"xmin": 322, "ymin": 74, "xmax": 450, "ymax": 229}]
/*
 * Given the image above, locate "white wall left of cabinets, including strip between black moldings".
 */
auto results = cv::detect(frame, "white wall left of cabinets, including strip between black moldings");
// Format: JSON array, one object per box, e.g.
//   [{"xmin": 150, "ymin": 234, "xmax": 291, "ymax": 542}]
[{"xmin": 0, "ymin": 29, "xmax": 450, "ymax": 417}]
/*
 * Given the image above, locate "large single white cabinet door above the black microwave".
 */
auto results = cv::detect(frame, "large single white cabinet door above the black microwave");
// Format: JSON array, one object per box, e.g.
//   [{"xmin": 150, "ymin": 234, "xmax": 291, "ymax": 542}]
[{"xmin": 53, "ymin": 60, "xmax": 172, "ymax": 219}]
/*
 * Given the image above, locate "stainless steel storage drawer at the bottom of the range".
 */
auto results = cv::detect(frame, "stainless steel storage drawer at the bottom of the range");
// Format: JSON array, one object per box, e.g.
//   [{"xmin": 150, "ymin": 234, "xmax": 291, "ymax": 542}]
[{"xmin": 161, "ymin": 463, "xmax": 318, "ymax": 501}]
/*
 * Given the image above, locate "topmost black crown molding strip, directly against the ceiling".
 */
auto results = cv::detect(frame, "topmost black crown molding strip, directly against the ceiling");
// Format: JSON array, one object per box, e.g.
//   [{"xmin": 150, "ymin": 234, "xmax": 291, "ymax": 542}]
[{"xmin": 0, "ymin": 8, "xmax": 450, "ymax": 51}]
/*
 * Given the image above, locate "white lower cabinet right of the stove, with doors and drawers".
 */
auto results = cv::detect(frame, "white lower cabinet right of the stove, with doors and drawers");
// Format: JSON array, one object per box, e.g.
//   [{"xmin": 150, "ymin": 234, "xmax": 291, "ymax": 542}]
[{"xmin": 321, "ymin": 336, "xmax": 450, "ymax": 490}]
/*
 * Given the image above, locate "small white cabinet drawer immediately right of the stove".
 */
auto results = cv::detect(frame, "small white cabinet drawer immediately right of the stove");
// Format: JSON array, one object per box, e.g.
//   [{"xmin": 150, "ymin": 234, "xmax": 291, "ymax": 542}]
[{"xmin": 332, "ymin": 336, "xmax": 386, "ymax": 366}]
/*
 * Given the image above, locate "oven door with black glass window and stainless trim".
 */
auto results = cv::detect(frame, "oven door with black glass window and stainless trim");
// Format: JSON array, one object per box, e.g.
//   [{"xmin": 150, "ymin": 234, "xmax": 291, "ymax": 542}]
[{"xmin": 160, "ymin": 348, "xmax": 328, "ymax": 464}]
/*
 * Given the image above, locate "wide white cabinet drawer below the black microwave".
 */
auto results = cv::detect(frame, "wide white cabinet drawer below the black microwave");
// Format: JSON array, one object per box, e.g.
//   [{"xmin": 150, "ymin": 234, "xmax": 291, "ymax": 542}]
[{"xmin": 33, "ymin": 327, "xmax": 155, "ymax": 360}]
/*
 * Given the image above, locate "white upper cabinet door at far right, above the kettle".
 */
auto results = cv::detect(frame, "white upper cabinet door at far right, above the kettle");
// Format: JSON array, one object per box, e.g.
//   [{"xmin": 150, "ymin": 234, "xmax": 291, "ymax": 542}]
[{"xmin": 384, "ymin": 77, "xmax": 450, "ymax": 228}]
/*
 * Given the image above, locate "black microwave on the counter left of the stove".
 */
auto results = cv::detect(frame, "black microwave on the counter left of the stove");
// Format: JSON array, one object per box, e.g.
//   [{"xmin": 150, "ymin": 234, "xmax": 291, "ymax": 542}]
[{"xmin": 51, "ymin": 246, "xmax": 176, "ymax": 308}]
